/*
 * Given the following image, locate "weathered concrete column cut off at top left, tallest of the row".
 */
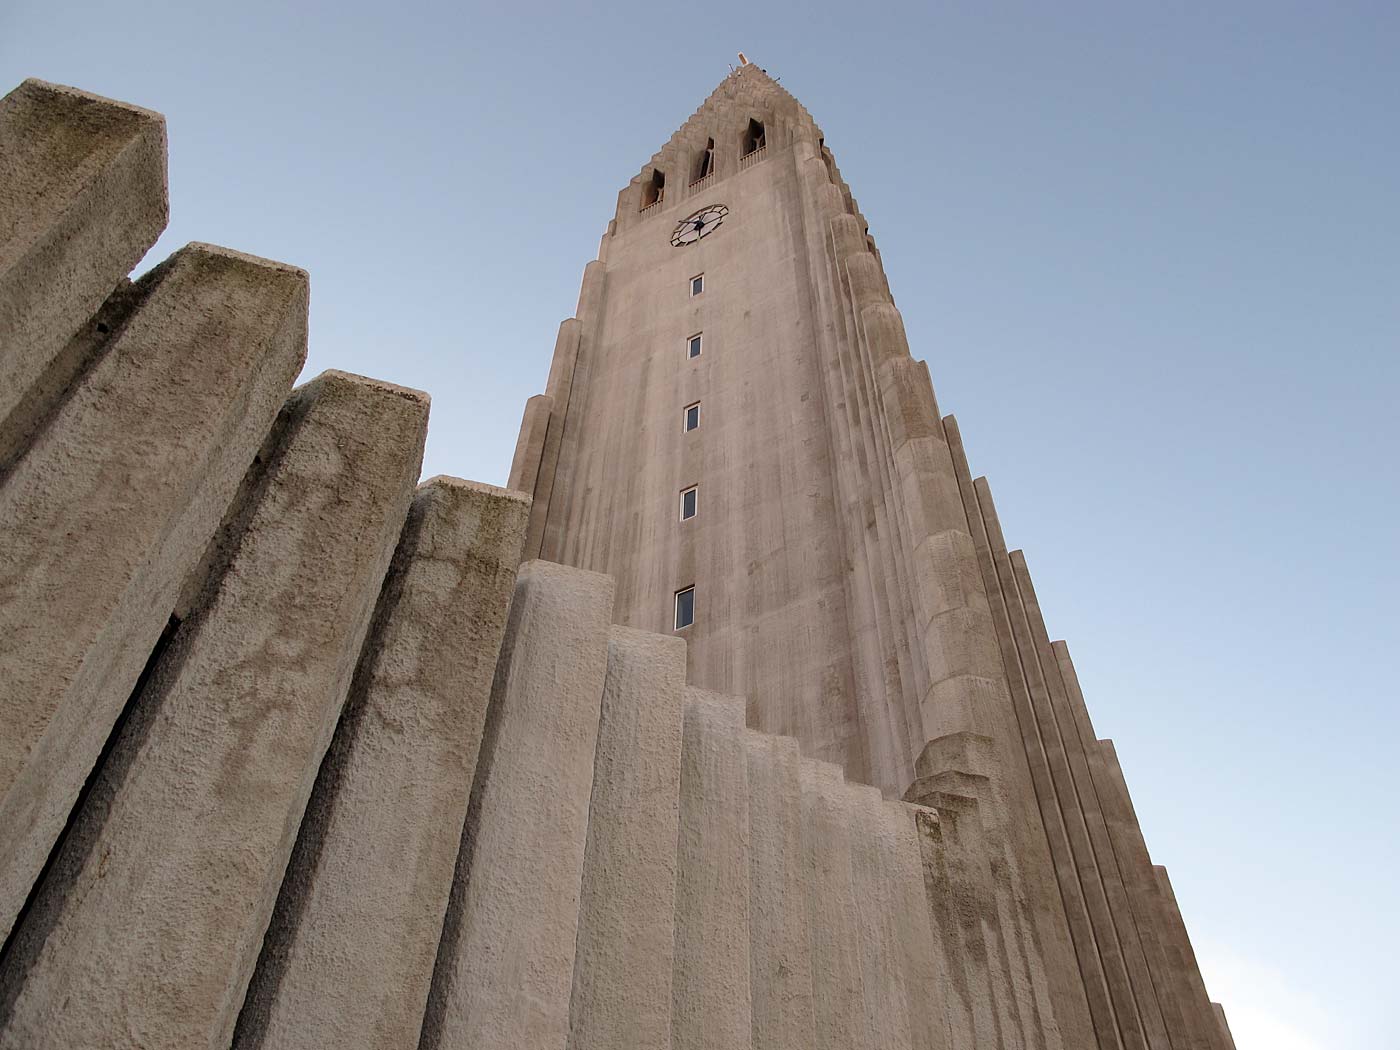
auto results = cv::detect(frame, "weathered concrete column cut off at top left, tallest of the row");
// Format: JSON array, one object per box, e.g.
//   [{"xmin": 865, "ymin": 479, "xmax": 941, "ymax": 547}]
[{"xmin": 0, "ymin": 80, "xmax": 169, "ymax": 461}]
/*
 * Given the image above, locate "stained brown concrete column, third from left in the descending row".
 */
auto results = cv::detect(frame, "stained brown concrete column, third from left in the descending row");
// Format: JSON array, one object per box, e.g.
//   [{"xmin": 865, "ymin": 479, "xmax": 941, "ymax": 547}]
[{"xmin": 0, "ymin": 372, "xmax": 428, "ymax": 1050}]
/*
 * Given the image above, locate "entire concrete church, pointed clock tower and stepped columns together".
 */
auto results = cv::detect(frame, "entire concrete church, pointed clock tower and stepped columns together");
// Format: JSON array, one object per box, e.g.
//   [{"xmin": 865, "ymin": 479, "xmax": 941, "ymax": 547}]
[{"xmin": 0, "ymin": 64, "xmax": 1232, "ymax": 1050}]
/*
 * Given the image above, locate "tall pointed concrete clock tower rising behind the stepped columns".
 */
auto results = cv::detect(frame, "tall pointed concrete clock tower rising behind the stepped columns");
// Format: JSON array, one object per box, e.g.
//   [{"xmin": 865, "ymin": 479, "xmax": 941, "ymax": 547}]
[{"xmin": 510, "ymin": 63, "xmax": 1231, "ymax": 1050}]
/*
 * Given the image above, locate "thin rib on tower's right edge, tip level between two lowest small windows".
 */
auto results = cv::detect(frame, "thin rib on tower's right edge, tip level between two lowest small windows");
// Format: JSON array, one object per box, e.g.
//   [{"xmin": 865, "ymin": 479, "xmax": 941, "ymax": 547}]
[{"xmin": 1009, "ymin": 550, "xmax": 1170, "ymax": 1049}]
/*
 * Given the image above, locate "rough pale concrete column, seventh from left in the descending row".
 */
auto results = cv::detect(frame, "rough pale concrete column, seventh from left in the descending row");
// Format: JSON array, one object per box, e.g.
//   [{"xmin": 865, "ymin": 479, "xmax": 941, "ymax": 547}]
[{"xmin": 671, "ymin": 689, "xmax": 753, "ymax": 1050}]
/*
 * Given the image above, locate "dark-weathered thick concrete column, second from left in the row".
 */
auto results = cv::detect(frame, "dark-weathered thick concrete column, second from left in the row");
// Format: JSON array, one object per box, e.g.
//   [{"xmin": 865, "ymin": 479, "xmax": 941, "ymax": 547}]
[{"xmin": 0, "ymin": 245, "xmax": 307, "ymax": 946}]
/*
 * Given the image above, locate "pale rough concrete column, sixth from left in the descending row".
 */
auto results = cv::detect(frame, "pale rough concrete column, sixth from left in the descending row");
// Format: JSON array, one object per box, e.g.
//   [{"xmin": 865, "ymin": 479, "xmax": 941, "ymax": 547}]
[{"xmin": 568, "ymin": 627, "xmax": 686, "ymax": 1050}]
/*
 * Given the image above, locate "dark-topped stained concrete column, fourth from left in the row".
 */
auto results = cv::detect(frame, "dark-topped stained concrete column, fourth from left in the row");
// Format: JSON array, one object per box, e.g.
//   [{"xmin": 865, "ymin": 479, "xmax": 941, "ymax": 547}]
[{"xmin": 234, "ymin": 477, "xmax": 529, "ymax": 1050}]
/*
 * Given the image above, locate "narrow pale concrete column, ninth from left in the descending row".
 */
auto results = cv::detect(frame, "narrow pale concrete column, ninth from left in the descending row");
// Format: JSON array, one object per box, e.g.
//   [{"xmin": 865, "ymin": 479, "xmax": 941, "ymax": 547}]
[{"xmin": 799, "ymin": 760, "xmax": 868, "ymax": 1050}]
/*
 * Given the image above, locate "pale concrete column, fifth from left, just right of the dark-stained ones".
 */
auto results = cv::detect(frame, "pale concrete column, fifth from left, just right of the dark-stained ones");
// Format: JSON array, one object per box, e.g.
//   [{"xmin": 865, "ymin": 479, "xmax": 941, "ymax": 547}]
[{"xmin": 421, "ymin": 561, "xmax": 613, "ymax": 1050}]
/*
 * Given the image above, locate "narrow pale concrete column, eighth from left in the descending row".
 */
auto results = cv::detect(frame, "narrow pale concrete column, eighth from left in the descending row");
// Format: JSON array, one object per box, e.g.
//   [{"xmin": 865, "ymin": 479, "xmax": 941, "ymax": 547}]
[{"xmin": 743, "ymin": 731, "xmax": 815, "ymax": 1050}]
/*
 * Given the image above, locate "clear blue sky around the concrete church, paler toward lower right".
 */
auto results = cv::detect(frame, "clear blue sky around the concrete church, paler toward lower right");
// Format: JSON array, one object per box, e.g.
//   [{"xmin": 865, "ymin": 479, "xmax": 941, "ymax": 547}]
[{"xmin": 0, "ymin": 0, "xmax": 1400, "ymax": 1050}]
